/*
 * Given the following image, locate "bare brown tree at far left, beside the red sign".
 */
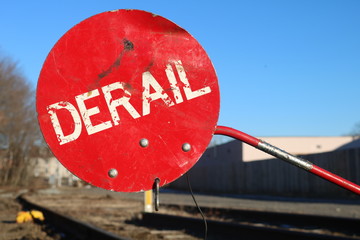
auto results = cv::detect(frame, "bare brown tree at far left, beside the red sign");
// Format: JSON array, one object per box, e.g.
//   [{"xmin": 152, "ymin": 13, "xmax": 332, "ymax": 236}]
[{"xmin": 0, "ymin": 55, "xmax": 42, "ymax": 185}]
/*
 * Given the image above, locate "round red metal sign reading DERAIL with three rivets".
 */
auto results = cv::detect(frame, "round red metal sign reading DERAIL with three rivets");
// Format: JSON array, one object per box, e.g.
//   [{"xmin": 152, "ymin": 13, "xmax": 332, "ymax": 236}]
[{"xmin": 36, "ymin": 10, "xmax": 219, "ymax": 192}]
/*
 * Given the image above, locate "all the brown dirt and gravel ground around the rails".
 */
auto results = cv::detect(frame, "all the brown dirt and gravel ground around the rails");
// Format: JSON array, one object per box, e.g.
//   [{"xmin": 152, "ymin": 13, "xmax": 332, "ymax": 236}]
[{"xmin": 0, "ymin": 188, "xmax": 360, "ymax": 240}]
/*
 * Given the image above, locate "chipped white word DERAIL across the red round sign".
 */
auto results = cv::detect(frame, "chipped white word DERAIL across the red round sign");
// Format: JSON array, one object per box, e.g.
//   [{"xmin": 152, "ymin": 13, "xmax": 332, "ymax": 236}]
[{"xmin": 47, "ymin": 60, "xmax": 211, "ymax": 145}]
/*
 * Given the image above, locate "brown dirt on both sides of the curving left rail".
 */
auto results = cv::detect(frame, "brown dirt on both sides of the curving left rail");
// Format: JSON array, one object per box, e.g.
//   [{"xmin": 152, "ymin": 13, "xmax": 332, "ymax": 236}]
[{"xmin": 0, "ymin": 189, "xmax": 200, "ymax": 240}]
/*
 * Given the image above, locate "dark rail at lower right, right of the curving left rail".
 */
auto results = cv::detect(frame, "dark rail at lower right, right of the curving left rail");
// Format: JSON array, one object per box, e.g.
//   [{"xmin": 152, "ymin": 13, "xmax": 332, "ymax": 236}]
[{"xmin": 143, "ymin": 205, "xmax": 360, "ymax": 240}]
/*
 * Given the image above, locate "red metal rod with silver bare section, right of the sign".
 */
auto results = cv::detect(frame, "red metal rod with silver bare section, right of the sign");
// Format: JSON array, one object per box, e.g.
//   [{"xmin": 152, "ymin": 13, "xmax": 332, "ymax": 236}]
[{"xmin": 214, "ymin": 126, "xmax": 360, "ymax": 195}]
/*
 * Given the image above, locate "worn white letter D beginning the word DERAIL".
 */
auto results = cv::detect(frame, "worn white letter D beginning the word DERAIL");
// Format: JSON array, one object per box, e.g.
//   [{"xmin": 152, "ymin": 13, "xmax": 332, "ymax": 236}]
[{"xmin": 47, "ymin": 102, "xmax": 81, "ymax": 145}]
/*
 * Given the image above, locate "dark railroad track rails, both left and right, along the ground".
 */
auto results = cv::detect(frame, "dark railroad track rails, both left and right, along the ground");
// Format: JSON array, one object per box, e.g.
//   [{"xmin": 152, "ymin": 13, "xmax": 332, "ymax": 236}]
[{"xmin": 19, "ymin": 194, "xmax": 360, "ymax": 240}]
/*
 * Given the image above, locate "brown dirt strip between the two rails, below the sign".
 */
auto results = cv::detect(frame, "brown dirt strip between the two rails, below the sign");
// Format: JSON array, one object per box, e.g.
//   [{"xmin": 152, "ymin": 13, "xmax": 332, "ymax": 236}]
[{"xmin": 26, "ymin": 188, "xmax": 199, "ymax": 240}]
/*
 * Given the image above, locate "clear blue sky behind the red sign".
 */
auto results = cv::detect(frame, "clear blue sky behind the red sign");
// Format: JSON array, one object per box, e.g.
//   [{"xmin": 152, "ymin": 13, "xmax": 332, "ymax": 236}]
[{"xmin": 0, "ymin": 0, "xmax": 360, "ymax": 136}]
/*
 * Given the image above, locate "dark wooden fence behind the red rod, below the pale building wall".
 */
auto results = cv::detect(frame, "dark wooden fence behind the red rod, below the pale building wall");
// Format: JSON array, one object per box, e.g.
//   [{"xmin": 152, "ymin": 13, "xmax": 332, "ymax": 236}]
[{"xmin": 170, "ymin": 141, "xmax": 360, "ymax": 198}]
